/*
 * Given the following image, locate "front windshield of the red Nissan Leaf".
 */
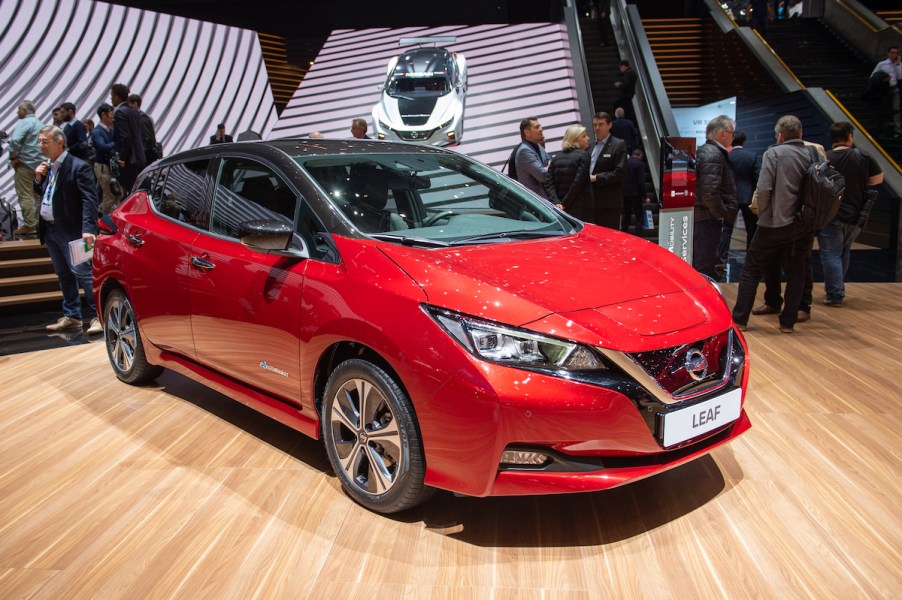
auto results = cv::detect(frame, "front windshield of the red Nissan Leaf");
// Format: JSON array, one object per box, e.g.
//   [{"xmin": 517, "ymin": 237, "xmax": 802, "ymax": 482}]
[{"xmin": 296, "ymin": 153, "xmax": 574, "ymax": 247}]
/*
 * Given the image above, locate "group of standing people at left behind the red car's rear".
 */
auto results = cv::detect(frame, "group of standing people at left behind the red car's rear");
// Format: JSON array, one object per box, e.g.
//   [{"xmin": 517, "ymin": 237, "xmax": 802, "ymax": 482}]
[{"xmin": 8, "ymin": 83, "xmax": 180, "ymax": 335}]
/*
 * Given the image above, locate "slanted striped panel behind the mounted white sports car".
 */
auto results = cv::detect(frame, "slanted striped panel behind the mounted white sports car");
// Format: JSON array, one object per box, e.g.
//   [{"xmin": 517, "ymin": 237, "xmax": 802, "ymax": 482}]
[{"xmin": 272, "ymin": 24, "xmax": 591, "ymax": 168}]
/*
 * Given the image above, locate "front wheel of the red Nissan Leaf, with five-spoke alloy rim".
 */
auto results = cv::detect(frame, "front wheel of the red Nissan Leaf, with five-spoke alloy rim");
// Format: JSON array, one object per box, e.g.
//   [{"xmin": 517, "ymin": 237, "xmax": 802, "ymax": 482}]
[{"xmin": 322, "ymin": 359, "xmax": 434, "ymax": 514}]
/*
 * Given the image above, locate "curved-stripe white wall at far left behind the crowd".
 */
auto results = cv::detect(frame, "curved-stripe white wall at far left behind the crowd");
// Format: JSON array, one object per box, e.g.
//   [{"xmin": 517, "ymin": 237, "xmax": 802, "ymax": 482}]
[{"xmin": 0, "ymin": 0, "xmax": 278, "ymax": 198}]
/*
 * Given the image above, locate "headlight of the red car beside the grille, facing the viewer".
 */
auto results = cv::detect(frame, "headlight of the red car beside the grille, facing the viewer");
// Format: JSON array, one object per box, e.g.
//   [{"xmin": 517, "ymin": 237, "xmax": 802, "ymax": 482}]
[{"xmin": 425, "ymin": 306, "xmax": 607, "ymax": 371}]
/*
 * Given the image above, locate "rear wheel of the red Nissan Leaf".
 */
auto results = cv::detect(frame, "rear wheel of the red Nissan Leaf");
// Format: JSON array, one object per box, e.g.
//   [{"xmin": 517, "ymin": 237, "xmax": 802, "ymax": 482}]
[{"xmin": 103, "ymin": 290, "xmax": 163, "ymax": 385}]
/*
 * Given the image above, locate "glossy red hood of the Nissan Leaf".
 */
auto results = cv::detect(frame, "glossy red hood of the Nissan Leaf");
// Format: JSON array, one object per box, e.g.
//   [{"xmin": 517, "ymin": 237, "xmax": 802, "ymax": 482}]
[{"xmin": 380, "ymin": 225, "xmax": 731, "ymax": 351}]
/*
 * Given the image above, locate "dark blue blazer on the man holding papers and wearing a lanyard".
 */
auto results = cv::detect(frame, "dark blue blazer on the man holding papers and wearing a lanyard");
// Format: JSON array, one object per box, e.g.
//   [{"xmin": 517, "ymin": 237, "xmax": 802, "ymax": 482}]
[{"xmin": 34, "ymin": 154, "xmax": 99, "ymax": 242}]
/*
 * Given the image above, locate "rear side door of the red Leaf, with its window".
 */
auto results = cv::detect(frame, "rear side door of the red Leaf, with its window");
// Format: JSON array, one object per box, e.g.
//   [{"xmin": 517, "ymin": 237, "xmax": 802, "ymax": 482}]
[{"xmin": 121, "ymin": 158, "xmax": 210, "ymax": 358}]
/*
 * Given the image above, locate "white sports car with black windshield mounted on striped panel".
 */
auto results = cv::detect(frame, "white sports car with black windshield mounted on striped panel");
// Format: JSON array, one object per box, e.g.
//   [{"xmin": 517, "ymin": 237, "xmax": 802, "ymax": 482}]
[{"xmin": 373, "ymin": 48, "xmax": 467, "ymax": 146}]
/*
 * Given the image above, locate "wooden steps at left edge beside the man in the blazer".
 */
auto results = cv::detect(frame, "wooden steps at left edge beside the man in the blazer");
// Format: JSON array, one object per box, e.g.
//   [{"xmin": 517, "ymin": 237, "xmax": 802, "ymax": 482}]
[{"xmin": 0, "ymin": 240, "xmax": 63, "ymax": 316}]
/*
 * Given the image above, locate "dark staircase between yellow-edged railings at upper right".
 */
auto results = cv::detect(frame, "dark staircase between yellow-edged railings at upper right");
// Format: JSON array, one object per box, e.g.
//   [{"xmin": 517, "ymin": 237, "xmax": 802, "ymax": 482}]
[{"xmin": 765, "ymin": 19, "xmax": 902, "ymax": 163}]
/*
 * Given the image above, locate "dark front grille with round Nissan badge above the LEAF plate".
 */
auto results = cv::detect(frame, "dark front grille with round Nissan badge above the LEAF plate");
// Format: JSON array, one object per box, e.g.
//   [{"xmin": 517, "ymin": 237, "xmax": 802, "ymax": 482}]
[{"xmin": 627, "ymin": 329, "xmax": 741, "ymax": 400}]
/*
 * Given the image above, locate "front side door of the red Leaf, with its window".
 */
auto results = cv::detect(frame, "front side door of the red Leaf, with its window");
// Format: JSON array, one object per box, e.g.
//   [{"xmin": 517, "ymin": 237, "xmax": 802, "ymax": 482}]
[{"xmin": 188, "ymin": 156, "xmax": 307, "ymax": 403}]
